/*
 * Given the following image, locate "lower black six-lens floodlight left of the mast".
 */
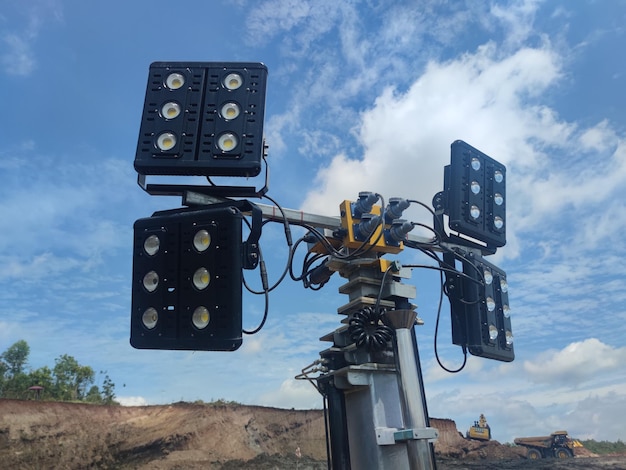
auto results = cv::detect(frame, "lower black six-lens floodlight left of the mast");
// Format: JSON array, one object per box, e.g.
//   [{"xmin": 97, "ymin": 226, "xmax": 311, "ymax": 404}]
[{"xmin": 130, "ymin": 205, "xmax": 250, "ymax": 351}]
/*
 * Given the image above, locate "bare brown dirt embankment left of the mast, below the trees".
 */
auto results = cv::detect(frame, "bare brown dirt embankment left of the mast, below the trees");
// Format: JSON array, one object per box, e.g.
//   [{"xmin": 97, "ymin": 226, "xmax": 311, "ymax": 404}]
[{"xmin": 0, "ymin": 399, "xmax": 326, "ymax": 469}]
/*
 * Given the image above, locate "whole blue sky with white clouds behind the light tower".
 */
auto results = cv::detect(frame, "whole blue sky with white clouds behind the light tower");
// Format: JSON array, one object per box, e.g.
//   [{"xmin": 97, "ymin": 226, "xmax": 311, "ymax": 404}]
[{"xmin": 0, "ymin": 0, "xmax": 626, "ymax": 442}]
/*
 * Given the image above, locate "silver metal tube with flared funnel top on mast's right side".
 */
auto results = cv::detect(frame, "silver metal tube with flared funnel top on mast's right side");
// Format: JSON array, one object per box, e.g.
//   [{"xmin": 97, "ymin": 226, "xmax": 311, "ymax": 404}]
[{"xmin": 386, "ymin": 310, "xmax": 435, "ymax": 470}]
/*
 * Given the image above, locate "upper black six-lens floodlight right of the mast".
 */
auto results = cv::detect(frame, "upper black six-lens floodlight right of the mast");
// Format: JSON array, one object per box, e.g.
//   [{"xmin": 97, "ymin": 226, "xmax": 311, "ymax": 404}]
[{"xmin": 444, "ymin": 140, "xmax": 506, "ymax": 248}]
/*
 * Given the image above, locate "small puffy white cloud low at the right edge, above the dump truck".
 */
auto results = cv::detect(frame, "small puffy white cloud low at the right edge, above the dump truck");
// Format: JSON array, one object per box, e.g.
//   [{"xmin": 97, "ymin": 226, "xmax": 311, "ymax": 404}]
[{"xmin": 524, "ymin": 338, "xmax": 626, "ymax": 386}]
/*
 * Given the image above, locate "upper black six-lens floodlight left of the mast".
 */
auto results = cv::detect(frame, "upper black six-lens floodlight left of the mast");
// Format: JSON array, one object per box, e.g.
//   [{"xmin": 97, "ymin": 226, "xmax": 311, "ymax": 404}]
[{"xmin": 135, "ymin": 62, "xmax": 267, "ymax": 177}]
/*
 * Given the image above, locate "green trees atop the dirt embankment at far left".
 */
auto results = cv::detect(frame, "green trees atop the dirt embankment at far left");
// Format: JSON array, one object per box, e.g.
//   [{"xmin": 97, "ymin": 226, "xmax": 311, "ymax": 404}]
[{"xmin": 0, "ymin": 340, "xmax": 117, "ymax": 404}]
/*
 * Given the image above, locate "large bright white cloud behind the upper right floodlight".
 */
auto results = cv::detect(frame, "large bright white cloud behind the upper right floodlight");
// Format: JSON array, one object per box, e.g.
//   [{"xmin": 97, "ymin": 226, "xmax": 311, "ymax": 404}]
[{"xmin": 304, "ymin": 43, "xmax": 568, "ymax": 217}]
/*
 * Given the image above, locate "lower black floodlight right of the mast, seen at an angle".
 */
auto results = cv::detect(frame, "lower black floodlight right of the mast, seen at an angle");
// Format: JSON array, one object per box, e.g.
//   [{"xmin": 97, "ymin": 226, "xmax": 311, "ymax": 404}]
[{"xmin": 444, "ymin": 253, "xmax": 515, "ymax": 362}]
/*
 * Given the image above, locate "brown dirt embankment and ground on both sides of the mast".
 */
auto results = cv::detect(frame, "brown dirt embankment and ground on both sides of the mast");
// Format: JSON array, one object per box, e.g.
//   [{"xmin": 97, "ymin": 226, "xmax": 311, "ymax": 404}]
[{"xmin": 0, "ymin": 399, "xmax": 626, "ymax": 470}]
